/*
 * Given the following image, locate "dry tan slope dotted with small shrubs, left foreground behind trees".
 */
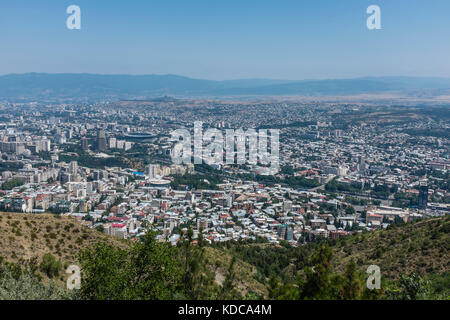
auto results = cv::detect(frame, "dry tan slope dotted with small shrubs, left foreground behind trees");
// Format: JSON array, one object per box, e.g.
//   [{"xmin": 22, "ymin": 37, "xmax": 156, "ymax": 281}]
[{"xmin": 0, "ymin": 212, "xmax": 267, "ymax": 299}]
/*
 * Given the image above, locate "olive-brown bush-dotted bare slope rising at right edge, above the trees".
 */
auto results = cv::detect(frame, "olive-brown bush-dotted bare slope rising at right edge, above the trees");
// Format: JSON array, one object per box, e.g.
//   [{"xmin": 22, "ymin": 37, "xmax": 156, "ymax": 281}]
[{"xmin": 332, "ymin": 216, "xmax": 450, "ymax": 279}]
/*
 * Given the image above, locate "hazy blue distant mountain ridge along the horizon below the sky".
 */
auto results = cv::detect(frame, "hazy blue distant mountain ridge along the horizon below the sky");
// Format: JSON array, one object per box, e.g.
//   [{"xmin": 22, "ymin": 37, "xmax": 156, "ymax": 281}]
[{"xmin": 0, "ymin": 73, "xmax": 450, "ymax": 101}]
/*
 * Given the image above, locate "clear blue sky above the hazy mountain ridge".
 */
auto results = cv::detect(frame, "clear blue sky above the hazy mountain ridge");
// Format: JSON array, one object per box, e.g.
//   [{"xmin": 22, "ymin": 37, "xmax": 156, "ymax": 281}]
[{"xmin": 0, "ymin": 0, "xmax": 450, "ymax": 80}]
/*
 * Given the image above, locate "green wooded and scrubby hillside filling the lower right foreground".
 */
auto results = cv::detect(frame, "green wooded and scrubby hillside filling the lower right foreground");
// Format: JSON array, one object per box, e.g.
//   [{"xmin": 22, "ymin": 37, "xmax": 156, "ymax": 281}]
[{"xmin": 211, "ymin": 216, "xmax": 450, "ymax": 299}]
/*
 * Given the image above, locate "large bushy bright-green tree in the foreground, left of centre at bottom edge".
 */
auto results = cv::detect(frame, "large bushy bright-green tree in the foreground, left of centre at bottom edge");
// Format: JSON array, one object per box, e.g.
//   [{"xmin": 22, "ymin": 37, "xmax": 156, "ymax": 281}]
[{"xmin": 79, "ymin": 231, "xmax": 183, "ymax": 300}]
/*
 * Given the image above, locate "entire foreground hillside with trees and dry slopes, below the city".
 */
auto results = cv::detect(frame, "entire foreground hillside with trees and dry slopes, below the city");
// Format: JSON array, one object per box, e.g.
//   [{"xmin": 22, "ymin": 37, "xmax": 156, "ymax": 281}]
[{"xmin": 0, "ymin": 213, "xmax": 450, "ymax": 299}]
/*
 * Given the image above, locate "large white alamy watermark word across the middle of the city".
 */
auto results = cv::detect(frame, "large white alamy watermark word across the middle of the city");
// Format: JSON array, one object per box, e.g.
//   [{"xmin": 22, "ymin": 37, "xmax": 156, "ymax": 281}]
[{"xmin": 171, "ymin": 121, "xmax": 280, "ymax": 174}]
